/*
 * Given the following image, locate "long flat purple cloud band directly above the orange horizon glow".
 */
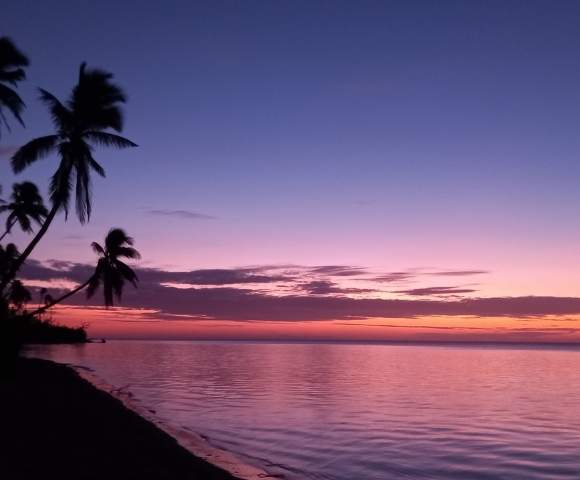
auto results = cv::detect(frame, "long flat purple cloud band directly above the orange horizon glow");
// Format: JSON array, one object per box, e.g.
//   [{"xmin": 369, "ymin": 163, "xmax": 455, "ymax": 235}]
[{"xmin": 74, "ymin": 284, "xmax": 580, "ymax": 322}]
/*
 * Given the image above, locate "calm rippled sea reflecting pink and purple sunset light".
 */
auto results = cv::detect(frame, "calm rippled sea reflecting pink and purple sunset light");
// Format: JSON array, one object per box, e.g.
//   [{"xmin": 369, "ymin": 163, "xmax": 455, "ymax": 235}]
[{"xmin": 27, "ymin": 341, "xmax": 580, "ymax": 480}]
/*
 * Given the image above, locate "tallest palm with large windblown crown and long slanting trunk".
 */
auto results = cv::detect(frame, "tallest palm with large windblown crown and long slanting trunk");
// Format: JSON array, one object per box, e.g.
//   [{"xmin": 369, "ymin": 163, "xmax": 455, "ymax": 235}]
[{"xmin": 0, "ymin": 63, "xmax": 137, "ymax": 292}]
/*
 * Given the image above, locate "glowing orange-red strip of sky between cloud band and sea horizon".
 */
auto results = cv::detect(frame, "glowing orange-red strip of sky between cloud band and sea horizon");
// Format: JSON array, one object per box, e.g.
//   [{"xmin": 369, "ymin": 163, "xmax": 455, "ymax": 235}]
[{"xmin": 47, "ymin": 306, "xmax": 580, "ymax": 343}]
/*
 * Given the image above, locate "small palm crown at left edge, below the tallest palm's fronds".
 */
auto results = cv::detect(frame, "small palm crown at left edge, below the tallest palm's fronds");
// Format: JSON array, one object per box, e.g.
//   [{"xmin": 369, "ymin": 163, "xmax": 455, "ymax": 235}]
[{"xmin": 0, "ymin": 182, "xmax": 48, "ymax": 241}]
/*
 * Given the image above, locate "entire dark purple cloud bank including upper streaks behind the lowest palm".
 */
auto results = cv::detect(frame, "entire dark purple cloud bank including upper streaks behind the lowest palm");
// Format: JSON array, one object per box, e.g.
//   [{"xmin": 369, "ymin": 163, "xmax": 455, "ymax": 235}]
[{"xmin": 22, "ymin": 260, "xmax": 580, "ymax": 322}]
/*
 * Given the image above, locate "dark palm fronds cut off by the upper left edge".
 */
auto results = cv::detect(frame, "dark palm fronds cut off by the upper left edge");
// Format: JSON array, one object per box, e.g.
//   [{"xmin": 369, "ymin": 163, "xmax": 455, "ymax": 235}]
[{"xmin": 0, "ymin": 37, "xmax": 28, "ymax": 134}]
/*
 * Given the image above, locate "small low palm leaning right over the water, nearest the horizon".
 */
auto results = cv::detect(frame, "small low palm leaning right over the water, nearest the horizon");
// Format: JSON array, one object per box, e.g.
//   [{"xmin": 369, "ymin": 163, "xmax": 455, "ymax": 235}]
[{"xmin": 32, "ymin": 228, "xmax": 141, "ymax": 315}]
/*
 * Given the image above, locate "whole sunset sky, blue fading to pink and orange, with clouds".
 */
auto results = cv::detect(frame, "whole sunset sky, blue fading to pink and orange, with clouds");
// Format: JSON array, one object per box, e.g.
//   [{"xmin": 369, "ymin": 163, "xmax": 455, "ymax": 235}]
[{"xmin": 0, "ymin": 0, "xmax": 580, "ymax": 342}]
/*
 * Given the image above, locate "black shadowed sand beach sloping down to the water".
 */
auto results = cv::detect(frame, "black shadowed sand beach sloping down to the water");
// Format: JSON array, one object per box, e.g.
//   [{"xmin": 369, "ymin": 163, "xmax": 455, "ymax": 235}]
[{"xmin": 0, "ymin": 359, "xmax": 240, "ymax": 480}]
